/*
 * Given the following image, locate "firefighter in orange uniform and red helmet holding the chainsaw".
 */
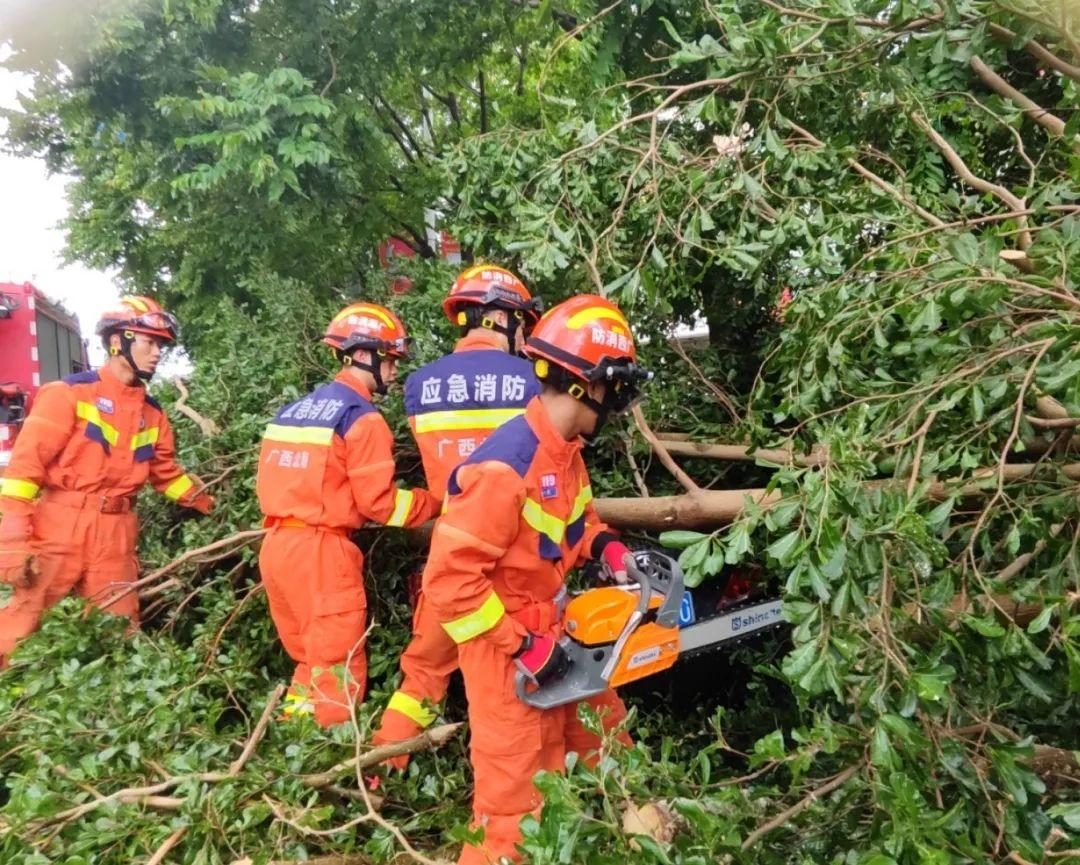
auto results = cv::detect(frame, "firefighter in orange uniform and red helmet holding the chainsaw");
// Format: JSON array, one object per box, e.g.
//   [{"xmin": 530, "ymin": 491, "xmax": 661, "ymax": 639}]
[{"xmin": 423, "ymin": 295, "xmax": 648, "ymax": 864}]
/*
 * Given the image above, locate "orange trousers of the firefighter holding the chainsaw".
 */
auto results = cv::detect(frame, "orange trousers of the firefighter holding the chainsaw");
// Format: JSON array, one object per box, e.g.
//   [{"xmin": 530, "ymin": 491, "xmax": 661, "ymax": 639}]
[{"xmin": 458, "ymin": 638, "xmax": 631, "ymax": 865}]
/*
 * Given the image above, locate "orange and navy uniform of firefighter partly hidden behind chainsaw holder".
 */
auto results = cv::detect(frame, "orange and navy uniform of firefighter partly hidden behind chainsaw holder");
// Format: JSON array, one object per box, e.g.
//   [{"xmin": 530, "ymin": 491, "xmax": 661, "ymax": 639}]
[{"xmin": 374, "ymin": 329, "xmax": 539, "ymax": 747}]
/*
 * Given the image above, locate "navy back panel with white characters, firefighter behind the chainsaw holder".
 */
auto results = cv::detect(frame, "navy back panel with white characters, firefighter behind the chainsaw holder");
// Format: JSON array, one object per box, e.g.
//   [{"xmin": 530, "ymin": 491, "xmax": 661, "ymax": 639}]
[{"xmin": 405, "ymin": 349, "xmax": 540, "ymax": 418}]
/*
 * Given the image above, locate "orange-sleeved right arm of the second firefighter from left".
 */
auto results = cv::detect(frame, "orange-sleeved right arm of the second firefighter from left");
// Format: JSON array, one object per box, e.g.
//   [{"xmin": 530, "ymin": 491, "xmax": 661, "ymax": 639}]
[{"xmin": 343, "ymin": 411, "xmax": 438, "ymax": 528}]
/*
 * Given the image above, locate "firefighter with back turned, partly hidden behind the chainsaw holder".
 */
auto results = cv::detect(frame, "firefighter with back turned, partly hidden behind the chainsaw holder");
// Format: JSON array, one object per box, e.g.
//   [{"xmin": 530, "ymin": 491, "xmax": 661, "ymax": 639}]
[{"xmin": 374, "ymin": 265, "xmax": 541, "ymax": 769}]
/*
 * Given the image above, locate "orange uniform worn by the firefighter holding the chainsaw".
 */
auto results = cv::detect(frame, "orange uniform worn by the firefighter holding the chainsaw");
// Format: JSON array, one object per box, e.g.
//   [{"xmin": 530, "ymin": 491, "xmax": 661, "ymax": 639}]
[{"xmin": 423, "ymin": 397, "xmax": 630, "ymax": 865}]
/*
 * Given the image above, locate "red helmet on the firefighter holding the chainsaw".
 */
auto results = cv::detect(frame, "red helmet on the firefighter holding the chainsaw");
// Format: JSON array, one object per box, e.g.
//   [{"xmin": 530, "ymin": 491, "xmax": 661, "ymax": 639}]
[{"xmin": 525, "ymin": 295, "xmax": 652, "ymax": 411}]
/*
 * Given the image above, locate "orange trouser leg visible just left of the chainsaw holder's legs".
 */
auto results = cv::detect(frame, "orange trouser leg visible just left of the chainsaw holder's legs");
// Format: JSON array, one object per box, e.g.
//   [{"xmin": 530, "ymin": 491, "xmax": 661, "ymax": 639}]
[{"xmin": 373, "ymin": 592, "xmax": 458, "ymax": 745}]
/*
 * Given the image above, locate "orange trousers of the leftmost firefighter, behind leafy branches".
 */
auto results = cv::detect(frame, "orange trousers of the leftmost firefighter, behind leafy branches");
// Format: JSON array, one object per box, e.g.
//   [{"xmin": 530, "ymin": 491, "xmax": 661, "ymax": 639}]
[{"xmin": 0, "ymin": 497, "xmax": 138, "ymax": 666}]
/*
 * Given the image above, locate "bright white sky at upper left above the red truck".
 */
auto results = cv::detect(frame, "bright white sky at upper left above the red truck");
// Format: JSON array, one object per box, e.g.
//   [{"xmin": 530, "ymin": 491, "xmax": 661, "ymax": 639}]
[{"xmin": 0, "ymin": 44, "xmax": 120, "ymax": 365}]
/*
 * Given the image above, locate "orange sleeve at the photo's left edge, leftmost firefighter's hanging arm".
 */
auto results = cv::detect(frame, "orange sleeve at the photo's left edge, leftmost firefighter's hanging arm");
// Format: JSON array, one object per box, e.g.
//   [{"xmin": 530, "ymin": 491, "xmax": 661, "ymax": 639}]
[{"xmin": 0, "ymin": 381, "xmax": 76, "ymax": 522}]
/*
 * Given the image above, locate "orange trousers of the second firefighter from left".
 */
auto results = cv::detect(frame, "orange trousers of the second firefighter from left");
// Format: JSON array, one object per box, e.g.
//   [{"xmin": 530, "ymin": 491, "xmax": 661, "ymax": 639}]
[{"xmin": 259, "ymin": 528, "xmax": 367, "ymax": 727}]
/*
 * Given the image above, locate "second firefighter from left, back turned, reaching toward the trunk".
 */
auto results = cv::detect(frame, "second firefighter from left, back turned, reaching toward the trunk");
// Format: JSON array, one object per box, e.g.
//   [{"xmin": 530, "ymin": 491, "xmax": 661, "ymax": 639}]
[{"xmin": 256, "ymin": 303, "xmax": 438, "ymax": 727}]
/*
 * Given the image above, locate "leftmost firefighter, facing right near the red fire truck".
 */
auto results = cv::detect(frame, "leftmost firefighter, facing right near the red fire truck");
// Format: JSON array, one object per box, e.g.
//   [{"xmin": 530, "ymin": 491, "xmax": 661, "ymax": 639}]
[{"xmin": 0, "ymin": 296, "xmax": 213, "ymax": 668}]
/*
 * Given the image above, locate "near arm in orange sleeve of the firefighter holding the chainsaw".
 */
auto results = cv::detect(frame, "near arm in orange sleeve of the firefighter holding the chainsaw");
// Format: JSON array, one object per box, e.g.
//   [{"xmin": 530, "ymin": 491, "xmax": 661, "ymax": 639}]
[{"xmin": 423, "ymin": 461, "xmax": 527, "ymax": 654}]
